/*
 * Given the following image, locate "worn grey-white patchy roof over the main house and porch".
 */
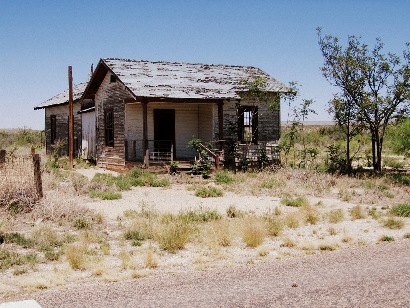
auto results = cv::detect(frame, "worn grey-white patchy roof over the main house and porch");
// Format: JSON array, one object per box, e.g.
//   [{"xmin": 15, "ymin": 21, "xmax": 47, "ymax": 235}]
[{"xmin": 102, "ymin": 58, "xmax": 289, "ymax": 99}]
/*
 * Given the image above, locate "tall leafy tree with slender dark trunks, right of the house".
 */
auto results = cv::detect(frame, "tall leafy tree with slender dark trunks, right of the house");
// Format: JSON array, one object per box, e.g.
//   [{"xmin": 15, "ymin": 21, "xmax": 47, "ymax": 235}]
[{"xmin": 318, "ymin": 28, "xmax": 410, "ymax": 172}]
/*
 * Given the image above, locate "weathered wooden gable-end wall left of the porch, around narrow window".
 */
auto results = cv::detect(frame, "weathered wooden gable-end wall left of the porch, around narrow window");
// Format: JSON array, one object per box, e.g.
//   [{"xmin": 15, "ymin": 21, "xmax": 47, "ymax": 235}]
[{"xmin": 95, "ymin": 73, "xmax": 131, "ymax": 167}]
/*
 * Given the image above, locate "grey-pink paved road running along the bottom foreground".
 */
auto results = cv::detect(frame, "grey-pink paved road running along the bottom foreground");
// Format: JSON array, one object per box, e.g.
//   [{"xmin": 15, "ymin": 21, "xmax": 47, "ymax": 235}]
[{"xmin": 15, "ymin": 240, "xmax": 410, "ymax": 307}]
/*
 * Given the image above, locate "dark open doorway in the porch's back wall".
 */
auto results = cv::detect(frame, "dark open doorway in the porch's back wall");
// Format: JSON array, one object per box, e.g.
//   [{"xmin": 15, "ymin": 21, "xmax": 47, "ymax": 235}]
[{"xmin": 154, "ymin": 109, "xmax": 175, "ymax": 157}]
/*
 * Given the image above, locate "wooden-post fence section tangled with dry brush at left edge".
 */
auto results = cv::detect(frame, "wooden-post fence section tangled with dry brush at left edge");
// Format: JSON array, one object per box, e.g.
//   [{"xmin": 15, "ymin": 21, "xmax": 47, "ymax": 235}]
[{"xmin": 0, "ymin": 150, "xmax": 43, "ymax": 211}]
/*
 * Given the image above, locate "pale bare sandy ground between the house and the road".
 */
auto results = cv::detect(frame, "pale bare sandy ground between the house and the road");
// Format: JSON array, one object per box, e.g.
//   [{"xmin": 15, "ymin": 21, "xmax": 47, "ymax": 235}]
[{"xmin": 0, "ymin": 169, "xmax": 410, "ymax": 307}]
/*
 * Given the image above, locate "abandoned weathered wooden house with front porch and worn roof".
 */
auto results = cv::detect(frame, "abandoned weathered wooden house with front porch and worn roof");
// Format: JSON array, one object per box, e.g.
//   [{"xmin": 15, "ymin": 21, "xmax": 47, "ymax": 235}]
[{"xmin": 36, "ymin": 58, "xmax": 288, "ymax": 168}]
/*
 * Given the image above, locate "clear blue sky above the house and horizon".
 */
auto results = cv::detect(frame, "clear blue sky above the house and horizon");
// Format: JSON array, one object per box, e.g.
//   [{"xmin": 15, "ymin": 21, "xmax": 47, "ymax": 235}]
[{"xmin": 0, "ymin": 0, "xmax": 410, "ymax": 129}]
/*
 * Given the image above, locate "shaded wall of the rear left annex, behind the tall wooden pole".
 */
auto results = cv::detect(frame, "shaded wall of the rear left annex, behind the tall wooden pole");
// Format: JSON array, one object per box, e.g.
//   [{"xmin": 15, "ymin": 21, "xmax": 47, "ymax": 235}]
[{"xmin": 45, "ymin": 102, "xmax": 81, "ymax": 156}]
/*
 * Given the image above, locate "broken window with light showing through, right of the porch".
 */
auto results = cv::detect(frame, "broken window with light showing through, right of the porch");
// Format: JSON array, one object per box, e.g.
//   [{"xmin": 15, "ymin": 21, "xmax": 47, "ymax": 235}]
[{"xmin": 238, "ymin": 106, "xmax": 258, "ymax": 143}]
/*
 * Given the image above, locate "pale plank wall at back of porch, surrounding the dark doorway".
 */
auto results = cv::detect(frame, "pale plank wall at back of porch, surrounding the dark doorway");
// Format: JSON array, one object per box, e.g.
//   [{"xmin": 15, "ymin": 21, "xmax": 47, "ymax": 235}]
[{"xmin": 125, "ymin": 102, "xmax": 213, "ymax": 160}]
